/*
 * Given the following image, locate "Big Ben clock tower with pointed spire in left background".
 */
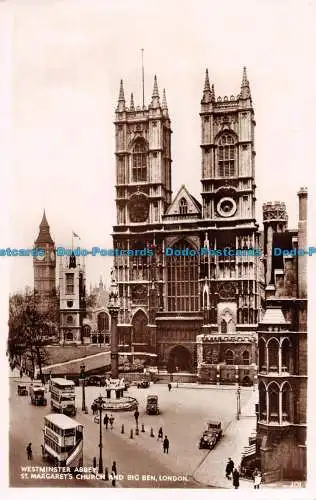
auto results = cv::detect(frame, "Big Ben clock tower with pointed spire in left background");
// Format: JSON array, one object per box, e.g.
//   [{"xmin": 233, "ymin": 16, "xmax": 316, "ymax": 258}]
[{"xmin": 33, "ymin": 210, "xmax": 56, "ymax": 313}]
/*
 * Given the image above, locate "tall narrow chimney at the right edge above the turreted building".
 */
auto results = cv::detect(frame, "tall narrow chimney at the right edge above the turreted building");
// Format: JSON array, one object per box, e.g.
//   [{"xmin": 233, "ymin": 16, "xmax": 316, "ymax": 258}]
[{"xmin": 297, "ymin": 188, "xmax": 307, "ymax": 299}]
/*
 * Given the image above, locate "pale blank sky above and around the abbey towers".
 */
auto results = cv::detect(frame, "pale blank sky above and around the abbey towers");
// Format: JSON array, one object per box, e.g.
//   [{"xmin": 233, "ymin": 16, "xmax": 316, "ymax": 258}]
[{"xmin": 4, "ymin": 0, "xmax": 315, "ymax": 292}]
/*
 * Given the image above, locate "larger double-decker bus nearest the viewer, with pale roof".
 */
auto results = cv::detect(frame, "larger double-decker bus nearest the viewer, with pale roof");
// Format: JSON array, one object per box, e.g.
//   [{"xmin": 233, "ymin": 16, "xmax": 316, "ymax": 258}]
[{"xmin": 42, "ymin": 413, "xmax": 83, "ymax": 472}]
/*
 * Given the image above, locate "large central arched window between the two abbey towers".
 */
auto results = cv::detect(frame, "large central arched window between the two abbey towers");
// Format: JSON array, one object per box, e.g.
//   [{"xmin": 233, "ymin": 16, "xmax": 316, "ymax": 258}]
[{"xmin": 166, "ymin": 241, "xmax": 199, "ymax": 312}]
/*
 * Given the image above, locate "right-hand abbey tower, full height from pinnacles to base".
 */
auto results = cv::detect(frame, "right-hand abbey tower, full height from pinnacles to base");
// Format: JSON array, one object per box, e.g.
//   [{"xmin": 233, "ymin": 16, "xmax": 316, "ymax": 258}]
[{"xmin": 198, "ymin": 68, "xmax": 260, "ymax": 383}]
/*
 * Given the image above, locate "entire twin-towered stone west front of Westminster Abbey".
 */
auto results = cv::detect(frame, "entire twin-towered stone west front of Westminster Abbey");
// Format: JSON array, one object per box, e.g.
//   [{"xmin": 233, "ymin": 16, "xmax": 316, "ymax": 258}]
[{"xmin": 113, "ymin": 70, "xmax": 259, "ymax": 381}]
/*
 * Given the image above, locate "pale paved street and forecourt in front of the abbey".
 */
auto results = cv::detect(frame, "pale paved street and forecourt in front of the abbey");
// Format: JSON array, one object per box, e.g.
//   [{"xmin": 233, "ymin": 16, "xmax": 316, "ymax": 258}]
[{"xmin": 10, "ymin": 372, "xmax": 253, "ymax": 488}]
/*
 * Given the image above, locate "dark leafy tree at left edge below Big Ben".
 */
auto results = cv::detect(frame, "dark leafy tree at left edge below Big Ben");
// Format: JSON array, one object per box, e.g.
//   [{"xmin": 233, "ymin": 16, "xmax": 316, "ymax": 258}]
[{"xmin": 7, "ymin": 290, "xmax": 48, "ymax": 381}]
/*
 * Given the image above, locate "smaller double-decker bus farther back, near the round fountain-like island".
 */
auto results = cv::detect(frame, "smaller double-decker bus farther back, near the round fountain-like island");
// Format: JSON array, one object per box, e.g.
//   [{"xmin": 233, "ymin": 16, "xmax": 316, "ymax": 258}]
[{"xmin": 50, "ymin": 378, "xmax": 76, "ymax": 416}]
